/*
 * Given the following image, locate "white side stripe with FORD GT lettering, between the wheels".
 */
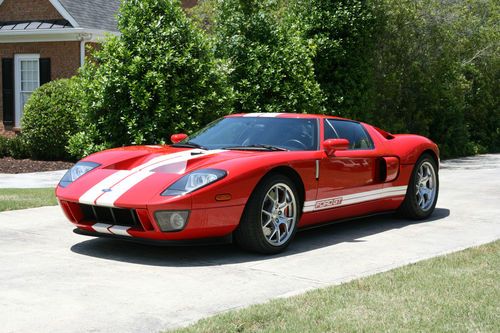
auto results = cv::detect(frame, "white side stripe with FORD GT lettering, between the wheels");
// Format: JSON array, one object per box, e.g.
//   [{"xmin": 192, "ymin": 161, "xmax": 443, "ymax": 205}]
[{"xmin": 303, "ymin": 186, "xmax": 407, "ymax": 213}]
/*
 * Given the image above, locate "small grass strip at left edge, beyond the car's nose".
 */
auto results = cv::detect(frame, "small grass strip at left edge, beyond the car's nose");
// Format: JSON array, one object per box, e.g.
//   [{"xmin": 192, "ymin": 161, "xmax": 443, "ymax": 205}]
[{"xmin": 0, "ymin": 188, "xmax": 57, "ymax": 212}]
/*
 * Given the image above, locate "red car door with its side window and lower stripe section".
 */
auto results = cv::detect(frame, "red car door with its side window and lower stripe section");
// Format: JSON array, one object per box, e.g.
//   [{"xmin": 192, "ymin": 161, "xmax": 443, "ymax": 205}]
[{"xmin": 312, "ymin": 119, "xmax": 383, "ymax": 213}]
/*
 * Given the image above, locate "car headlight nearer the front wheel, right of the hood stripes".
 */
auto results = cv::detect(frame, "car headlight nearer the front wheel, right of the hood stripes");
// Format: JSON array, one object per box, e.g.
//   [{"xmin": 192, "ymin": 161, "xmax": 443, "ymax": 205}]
[{"xmin": 161, "ymin": 169, "xmax": 227, "ymax": 196}]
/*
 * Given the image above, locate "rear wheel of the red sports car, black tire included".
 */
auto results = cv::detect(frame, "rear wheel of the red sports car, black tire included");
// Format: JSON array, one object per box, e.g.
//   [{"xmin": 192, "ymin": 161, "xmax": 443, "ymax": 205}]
[{"xmin": 399, "ymin": 154, "xmax": 439, "ymax": 220}]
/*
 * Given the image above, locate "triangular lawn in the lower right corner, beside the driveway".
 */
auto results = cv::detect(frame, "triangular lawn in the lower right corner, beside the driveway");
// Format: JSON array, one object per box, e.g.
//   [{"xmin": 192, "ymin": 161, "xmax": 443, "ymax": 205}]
[{"xmin": 171, "ymin": 241, "xmax": 500, "ymax": 332}]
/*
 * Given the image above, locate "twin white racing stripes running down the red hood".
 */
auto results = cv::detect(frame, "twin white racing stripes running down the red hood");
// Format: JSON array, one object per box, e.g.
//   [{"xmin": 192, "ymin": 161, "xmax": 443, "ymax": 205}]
[{"xmin": 79, "ymin": 149, "xmax": 227, "ymax": 207}]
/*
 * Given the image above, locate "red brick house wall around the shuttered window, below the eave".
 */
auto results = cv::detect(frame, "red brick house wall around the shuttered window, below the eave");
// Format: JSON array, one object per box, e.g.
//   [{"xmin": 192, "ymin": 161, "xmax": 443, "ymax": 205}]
[{"xmin": 0, "ymin": 41, "xmax": 80, "ymax": 134}]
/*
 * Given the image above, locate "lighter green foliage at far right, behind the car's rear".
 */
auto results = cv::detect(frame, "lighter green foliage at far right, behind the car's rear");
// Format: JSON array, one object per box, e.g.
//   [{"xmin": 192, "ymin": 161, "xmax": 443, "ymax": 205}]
[{"xmin": 366, "ymin": 0, "xmax": 500, "ymax": 157}]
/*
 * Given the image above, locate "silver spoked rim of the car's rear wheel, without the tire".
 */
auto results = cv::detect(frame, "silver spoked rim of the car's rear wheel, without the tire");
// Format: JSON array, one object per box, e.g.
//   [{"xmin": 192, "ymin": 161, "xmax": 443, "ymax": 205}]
[{"xmin": 415, "ymin": 161, "xmax": 437, "ymax": 211}]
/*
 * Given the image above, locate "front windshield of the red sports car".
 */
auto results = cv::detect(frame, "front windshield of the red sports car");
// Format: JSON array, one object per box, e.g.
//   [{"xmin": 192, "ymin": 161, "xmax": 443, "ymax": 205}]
[{"xmin": 184, "ymin": 117, "xmax": 318, "ymax": 150}]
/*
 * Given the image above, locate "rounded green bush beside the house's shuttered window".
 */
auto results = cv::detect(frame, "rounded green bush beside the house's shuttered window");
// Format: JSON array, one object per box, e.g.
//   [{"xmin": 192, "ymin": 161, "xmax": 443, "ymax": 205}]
[{"xmin": 21, "ymin": 79, "xmax": 81, "ymax": 160}]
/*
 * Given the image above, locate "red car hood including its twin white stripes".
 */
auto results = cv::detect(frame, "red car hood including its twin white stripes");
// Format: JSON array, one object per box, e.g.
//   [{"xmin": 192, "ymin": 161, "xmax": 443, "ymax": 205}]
[{"xmin": 57, "ymin": 146, "xmax": 292, "ymax": 207}]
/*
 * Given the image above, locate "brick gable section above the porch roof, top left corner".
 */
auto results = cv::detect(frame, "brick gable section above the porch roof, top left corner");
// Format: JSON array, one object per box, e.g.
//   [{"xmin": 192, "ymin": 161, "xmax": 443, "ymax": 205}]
[{"xmin": 0, "ymin": 0, "xmax": 63, "ymax": 21}]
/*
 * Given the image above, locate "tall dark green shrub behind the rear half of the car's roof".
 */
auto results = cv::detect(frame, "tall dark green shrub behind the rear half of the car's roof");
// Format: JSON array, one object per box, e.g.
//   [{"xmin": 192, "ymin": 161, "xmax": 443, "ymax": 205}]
[{"xmin": 285, "ymin": 0, "xmax": 380, "ymax": 118}]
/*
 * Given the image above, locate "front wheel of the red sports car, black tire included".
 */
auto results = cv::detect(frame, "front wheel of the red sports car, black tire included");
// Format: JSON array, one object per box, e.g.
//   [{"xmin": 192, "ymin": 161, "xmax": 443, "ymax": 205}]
[{"xmin": 234, "ymin": 174, "xmax": 302, "ymax": 254}]
